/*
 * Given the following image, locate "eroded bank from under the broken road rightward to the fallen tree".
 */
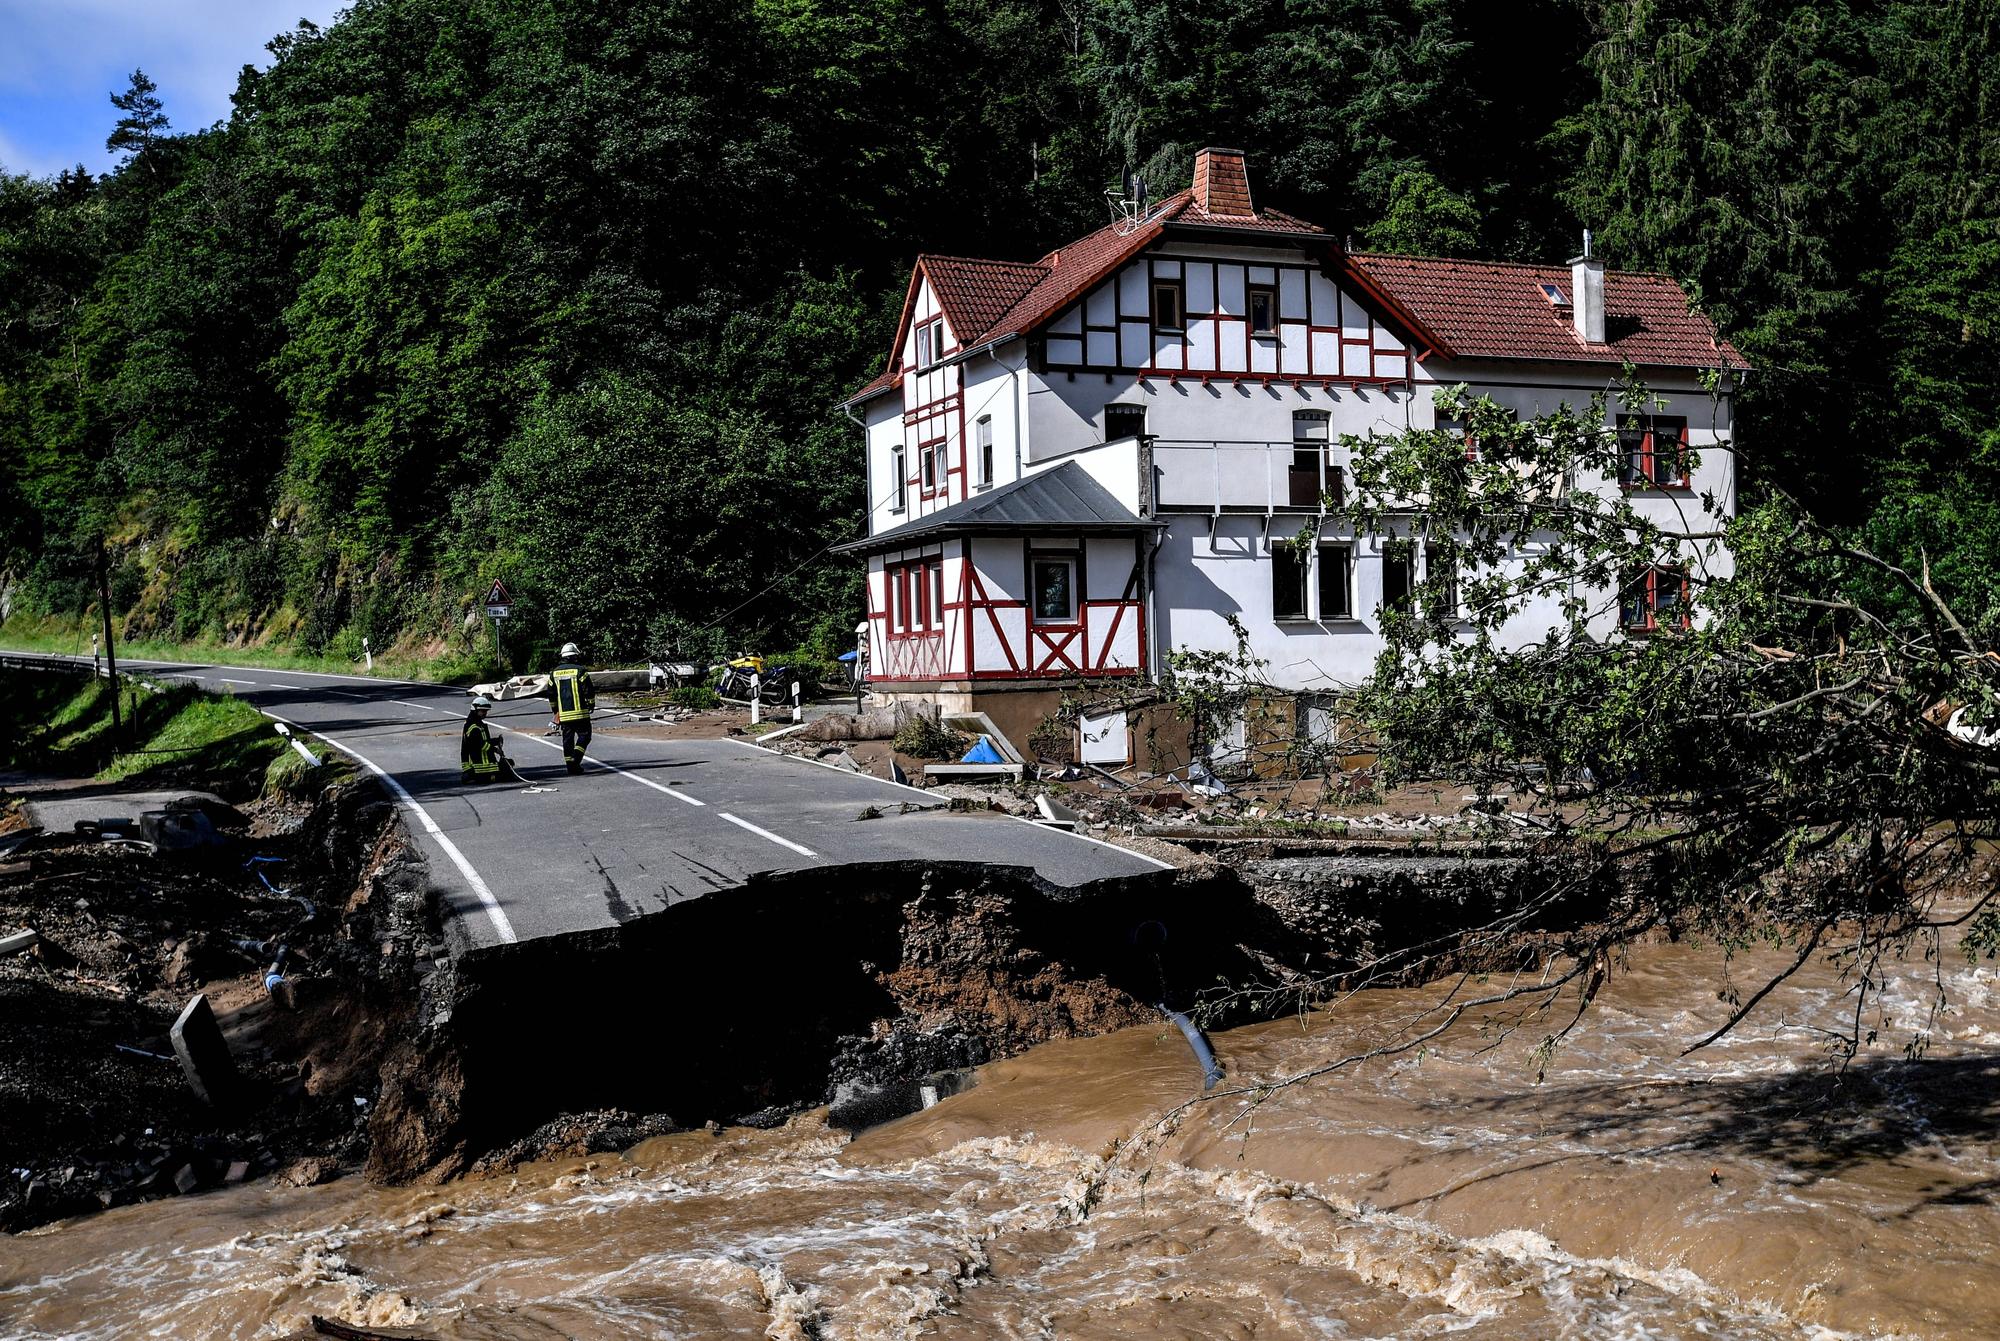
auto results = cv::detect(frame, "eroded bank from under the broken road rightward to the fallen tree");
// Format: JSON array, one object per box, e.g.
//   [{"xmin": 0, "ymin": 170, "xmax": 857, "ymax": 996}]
[{"xmin": 368, "ymin": 840, "xmax": 1598, "ymax": 1181}]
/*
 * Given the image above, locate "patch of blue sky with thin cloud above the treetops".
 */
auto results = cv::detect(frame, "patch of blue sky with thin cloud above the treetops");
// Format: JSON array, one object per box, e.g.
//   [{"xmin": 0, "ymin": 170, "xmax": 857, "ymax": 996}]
[{"xmin": 0, "ymin": 0, "xmax": 350, "ymax": 176}]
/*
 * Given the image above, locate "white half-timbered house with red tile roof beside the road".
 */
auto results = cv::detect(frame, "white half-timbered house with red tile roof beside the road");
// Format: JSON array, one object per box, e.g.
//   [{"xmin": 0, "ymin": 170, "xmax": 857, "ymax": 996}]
[{"xmin": 846, "ymin": 148, "xmax": 1744, "ymax": 760}]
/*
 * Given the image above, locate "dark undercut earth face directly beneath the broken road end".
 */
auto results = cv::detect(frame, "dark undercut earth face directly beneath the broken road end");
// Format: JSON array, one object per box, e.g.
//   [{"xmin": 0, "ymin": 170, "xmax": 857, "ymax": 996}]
[{"xmin": 370, "ymin": 863, "xmax": 1218, "ymax": 1179}]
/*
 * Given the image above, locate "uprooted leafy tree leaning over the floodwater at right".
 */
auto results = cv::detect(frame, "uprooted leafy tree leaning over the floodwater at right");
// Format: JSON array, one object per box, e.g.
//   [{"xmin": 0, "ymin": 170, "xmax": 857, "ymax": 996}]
[{"xmin": 1264, "ymin": 386, "xmax": 2000, "ymax": 1073}]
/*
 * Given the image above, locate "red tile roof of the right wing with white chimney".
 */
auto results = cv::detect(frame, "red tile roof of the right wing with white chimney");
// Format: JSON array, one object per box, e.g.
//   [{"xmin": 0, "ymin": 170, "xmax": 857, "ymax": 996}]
[{"xmin": 1348, "ymin": 252, "xmax": 1748, "ymax": 368}]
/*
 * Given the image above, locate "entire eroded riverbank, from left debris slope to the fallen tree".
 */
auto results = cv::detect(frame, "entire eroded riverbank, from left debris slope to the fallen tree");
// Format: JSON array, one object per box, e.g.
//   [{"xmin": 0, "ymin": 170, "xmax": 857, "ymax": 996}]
[{"xmin": 0, "ymin": 736, "xmax": 1616, "ymax": 1229}]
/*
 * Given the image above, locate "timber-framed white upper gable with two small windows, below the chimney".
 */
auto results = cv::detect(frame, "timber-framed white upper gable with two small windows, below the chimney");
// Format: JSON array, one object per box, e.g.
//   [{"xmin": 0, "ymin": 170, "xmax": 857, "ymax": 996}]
[{"xmin": 1042, "ymin": 256, "xmax": 1420, "ymax": 384}]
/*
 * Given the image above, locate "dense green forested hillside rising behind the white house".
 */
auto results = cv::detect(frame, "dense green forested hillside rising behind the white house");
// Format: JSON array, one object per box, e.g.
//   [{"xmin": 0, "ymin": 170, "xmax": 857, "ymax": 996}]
[{"xmin": 0, "ymin": 0, "xmax": 2000, "ymax": 672}]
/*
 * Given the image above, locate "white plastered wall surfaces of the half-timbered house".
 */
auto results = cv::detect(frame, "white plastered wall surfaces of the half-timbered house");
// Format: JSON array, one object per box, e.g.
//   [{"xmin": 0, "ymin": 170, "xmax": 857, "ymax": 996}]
[{"xmin": 860, "ymin": 246, "xmax": 1736, "ymax": 689}]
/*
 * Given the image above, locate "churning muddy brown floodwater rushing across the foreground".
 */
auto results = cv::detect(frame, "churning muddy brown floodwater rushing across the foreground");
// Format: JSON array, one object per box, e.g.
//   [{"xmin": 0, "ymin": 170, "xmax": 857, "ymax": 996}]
[{"xmin": 0, "ymin": 945, "xmax": 2000, "ymax": 1341}]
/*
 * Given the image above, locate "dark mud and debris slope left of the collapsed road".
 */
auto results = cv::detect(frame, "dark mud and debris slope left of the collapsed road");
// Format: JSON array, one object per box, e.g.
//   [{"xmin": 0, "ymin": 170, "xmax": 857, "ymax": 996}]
[{"xmin": 0, "ymin": 783, "xmax": 434, "ymax": 1229}]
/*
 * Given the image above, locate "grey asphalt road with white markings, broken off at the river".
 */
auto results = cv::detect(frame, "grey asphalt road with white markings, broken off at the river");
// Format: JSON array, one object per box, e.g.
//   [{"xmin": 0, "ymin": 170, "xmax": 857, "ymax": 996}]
[{"xmin": 3, "ymin": 656, "xmax": 1164, "ymax": 951}]
